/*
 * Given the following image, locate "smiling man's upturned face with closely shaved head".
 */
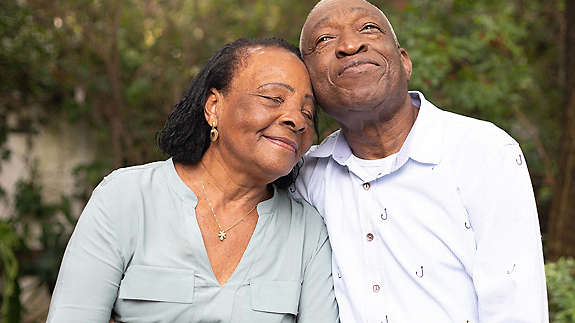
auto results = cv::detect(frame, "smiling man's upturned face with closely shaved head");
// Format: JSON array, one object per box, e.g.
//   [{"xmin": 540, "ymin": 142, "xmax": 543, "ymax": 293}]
[{"xmin": 300, "ymin": 0, "xmax": 411, "ymax": 121}]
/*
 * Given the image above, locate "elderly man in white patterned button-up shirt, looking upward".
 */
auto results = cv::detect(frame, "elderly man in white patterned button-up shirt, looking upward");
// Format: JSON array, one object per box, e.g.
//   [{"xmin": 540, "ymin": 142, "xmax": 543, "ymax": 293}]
[{"xmin": 296, "ymin": 0, "xmax": 548, "ymax": 323}]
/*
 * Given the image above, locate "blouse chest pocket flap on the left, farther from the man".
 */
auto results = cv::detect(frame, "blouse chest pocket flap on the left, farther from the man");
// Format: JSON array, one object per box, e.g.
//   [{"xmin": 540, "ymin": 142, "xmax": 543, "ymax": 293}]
[{"xmin": 118, "ymin": 265, "xmax": 194, "ymax": 304}]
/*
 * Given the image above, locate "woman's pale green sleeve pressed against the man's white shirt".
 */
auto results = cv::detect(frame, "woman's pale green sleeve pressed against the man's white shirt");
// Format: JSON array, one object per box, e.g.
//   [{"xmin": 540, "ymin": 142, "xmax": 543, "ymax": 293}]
[{"xmin": 297, "ymin": 207, "xmax": 339, "ymax": 323}]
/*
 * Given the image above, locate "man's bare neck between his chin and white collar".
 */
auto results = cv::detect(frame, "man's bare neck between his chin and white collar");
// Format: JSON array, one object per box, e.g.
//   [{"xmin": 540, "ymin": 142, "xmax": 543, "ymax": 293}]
[{"xmin": 341, "ymin": 95, "xmax": 419, "ymax": 159}]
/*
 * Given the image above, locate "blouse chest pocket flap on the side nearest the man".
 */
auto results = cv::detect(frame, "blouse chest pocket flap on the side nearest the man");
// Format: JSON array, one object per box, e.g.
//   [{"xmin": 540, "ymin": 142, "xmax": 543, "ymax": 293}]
[{"xmin": 250, "ymin": 280, "xmax": 301, "ymax": 315}]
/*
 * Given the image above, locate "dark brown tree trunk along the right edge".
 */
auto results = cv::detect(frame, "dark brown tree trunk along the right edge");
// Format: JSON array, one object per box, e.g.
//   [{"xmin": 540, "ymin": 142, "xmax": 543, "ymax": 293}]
[{"xmin": 547, "ymin": 0, "xmax": 575, "ymax": 259}]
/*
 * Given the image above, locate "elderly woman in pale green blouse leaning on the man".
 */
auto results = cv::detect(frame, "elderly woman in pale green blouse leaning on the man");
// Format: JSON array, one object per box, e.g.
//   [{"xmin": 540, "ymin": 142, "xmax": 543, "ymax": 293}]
[{"xmin": 48, "ymin": 38, "xmax": 338, "ymax": 323}]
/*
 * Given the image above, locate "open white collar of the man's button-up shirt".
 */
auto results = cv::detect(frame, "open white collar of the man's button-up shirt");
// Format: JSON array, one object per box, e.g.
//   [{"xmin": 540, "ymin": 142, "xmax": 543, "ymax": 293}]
[{"xmin": 308, "ymin": 91, "xmax": 444, "ymax": 169}]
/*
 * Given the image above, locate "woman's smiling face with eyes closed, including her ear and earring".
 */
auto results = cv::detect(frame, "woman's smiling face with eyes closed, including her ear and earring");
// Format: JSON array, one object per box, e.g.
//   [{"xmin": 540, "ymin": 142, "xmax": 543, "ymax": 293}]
[{"xmin": 212, "ymin": 47, "xmax": 315, "ymax": 182}]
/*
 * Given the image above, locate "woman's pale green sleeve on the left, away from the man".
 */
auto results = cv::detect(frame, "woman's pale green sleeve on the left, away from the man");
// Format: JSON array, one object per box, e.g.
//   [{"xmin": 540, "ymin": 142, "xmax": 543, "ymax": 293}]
[{"xmin": 47, "ymin": 184, "xmax": 128, "ymax": 323}]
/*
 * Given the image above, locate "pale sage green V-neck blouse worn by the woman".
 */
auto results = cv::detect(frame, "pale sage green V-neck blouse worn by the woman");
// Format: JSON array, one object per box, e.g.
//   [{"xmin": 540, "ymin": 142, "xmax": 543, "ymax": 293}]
[{"xmin": 48, "ymin": 159, "xmax": 339, "ymax": 323}]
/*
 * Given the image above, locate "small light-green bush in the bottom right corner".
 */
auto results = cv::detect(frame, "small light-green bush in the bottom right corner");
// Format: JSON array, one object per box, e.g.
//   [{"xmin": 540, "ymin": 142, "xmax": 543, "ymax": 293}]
[{"xmin": 545, "ymin": 258, "xmax": 575, "ymax": 323}]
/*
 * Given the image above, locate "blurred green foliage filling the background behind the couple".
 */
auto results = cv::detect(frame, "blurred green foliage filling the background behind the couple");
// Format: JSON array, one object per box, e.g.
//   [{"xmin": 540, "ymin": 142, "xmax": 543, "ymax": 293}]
[{"xmin": 0, "ymin": 0, "xmax": 575, "ymax": 322}]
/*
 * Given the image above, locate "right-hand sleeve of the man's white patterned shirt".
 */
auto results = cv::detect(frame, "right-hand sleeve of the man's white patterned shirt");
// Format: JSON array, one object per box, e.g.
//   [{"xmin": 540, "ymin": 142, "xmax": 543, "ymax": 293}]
[{"xmin": 460, "ymin": 144, "xmax": 549, "ymax": 323}]
